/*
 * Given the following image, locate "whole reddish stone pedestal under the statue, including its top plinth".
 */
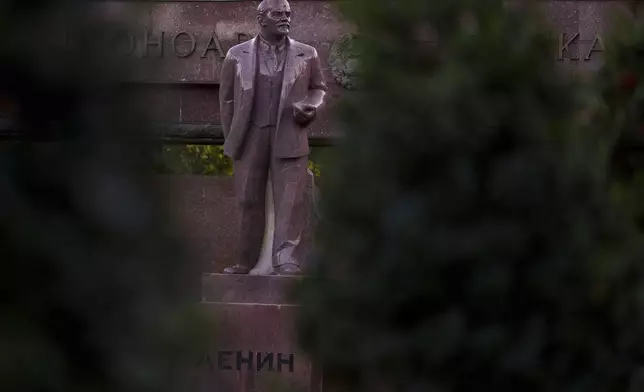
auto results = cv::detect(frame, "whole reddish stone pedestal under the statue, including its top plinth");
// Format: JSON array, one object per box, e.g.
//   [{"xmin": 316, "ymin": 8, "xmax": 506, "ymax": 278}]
[{"xmin": 196, "ymin": 274, "xmax": 322, "ymax": 392}]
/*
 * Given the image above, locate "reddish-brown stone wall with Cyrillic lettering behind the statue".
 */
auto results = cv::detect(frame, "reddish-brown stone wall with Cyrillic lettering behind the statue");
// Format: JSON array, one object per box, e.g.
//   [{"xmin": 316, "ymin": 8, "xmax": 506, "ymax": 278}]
[{"xmin": 140, "ymin": 1, "xmax": 642, "ymax": 272}]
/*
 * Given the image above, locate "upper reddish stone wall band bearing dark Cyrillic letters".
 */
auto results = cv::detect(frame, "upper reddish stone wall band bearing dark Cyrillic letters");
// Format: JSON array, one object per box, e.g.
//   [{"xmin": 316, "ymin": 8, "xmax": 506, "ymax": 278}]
[{"xmin": 103, "ymin": 0, "xmax": 634, "ymax": 84}]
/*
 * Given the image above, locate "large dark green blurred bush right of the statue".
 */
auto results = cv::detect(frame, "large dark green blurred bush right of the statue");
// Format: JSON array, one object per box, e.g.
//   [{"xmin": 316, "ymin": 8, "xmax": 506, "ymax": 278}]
[{"xmin": 298, "ymin": 0, "xmax": 644, "ymax": 392}]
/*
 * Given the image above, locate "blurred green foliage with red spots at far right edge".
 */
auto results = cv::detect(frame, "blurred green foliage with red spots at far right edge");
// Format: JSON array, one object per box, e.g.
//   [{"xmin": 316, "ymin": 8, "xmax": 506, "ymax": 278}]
[{"xmin": 589, "ymin": 16, "xmax": 644, "ymax": 232}]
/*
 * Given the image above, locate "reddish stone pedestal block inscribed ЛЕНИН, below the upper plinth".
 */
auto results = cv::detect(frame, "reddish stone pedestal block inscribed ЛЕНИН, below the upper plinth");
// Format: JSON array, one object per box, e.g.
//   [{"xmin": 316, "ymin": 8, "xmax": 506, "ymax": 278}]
[{"xmin": 193, "ymin": 303, "xmax": 322, "ymax": 392}]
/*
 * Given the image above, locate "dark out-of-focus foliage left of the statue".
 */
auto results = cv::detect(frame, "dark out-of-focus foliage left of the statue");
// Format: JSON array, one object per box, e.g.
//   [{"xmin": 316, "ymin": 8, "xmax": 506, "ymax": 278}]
[{"xmin": 0, "ymin": 0, "xmax": 205, "ymax": 392}]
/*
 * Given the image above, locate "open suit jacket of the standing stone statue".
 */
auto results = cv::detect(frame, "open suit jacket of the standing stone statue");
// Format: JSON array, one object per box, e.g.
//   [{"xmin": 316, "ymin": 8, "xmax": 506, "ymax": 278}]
[{"xmin": 219, "ymin": 37, "xmax": 327, "ymax": 159}]
